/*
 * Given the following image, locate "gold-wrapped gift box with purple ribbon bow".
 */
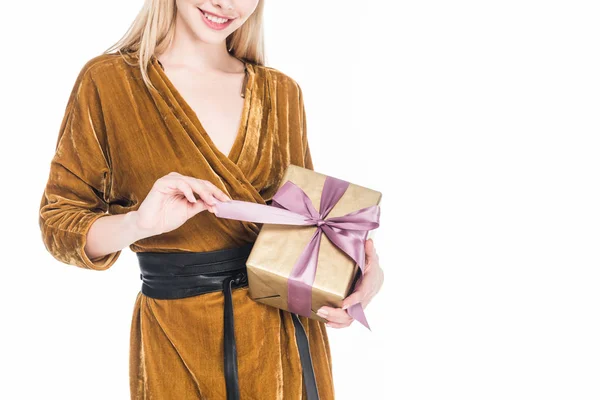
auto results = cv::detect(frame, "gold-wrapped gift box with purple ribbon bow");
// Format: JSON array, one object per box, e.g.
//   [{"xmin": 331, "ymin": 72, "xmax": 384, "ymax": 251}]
[{"xmin": 234, "ymin": 165, "xmax": 382, "ymax": 327}]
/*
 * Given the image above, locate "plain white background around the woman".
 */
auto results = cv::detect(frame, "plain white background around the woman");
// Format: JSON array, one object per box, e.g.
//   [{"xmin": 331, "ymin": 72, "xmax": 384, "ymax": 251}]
[{"xmin": 0, "ymin": 0, "xmax": 600, "ymax": 400}]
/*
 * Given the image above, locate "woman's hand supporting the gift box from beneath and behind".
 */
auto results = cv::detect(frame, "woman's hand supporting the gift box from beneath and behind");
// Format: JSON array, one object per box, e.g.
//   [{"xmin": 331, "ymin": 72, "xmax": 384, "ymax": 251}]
[{"xmin": 317, "ymin": 239, "xmax": 383, "ymax": 328}]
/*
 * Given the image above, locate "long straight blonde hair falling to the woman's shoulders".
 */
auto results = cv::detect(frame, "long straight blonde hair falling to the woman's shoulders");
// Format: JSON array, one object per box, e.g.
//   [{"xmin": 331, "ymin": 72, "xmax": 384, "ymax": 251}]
[{"xmin": 104, "ymin": 0, "xmax": 265, "ymax": 89}]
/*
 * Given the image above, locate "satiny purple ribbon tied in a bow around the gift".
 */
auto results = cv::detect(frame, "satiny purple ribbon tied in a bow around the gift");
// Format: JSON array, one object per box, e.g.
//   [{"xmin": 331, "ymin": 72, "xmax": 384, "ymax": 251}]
[{"xmin": 214, "ymin": 176, "xmax": 380, "ymax": 330}]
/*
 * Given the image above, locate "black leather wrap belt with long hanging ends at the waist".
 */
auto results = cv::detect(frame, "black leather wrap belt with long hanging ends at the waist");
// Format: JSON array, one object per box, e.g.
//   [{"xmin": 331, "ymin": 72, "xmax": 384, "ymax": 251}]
[{"xmin": 135, "ymin": 243, "xmax": 319, "ymax": 400}]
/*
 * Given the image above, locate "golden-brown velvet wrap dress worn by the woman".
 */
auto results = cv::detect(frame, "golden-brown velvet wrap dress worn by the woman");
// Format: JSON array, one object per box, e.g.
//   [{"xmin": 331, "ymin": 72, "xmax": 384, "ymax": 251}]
[{"xmin": 39, "ymin": 53, "xmax": 334, "ymax": 400}]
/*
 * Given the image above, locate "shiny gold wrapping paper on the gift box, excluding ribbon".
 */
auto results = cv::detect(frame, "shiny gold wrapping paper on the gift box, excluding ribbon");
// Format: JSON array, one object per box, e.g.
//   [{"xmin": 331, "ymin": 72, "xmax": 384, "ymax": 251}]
[{"xmin": 246, "ymin": 164, "xmax": 381, "ymax": 322}]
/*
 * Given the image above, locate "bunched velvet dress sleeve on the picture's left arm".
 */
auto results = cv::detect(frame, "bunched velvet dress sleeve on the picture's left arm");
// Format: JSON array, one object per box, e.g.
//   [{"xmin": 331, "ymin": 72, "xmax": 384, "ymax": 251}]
[{"xmin": 39, "ymin": 63, "xmax": 121, "ymax": 270}]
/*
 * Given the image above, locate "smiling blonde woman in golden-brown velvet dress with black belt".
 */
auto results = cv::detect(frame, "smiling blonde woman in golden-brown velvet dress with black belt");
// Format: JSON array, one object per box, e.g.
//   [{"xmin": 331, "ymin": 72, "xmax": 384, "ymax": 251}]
[{"xmin": 40, "ymin": 0, "xmax": 383, "ymax": 400}]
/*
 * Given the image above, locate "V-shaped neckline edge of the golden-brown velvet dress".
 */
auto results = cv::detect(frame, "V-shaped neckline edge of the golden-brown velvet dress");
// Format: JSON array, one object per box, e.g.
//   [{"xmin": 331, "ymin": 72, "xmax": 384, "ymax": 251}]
[{"xmin": 151, "ymin": 55, "xmax": 254, "ymax": 165}]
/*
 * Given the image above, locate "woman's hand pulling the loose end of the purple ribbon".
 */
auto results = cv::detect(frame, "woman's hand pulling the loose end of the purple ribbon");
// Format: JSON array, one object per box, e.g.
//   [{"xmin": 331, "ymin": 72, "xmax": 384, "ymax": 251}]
[{"xmin": 135, "ymin": 172, "xmax": 231, "ymax": 237}]
